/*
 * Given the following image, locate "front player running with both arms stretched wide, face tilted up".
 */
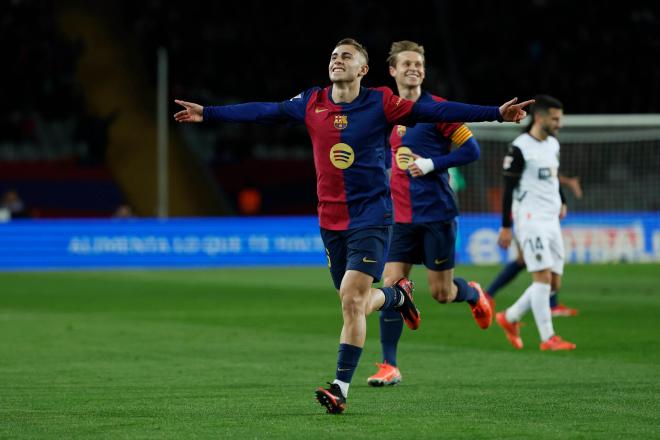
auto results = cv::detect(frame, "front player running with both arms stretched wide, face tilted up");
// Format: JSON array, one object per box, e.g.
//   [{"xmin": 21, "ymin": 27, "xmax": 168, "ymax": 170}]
[{"xmin": 174, "ymin": 39, "xmax": 533, "ymax": 414}]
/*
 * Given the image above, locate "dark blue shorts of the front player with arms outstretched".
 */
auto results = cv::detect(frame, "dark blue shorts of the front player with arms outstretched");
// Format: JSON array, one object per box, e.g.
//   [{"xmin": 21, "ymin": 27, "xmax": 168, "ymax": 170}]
[{"xmin": 321, "ymin": 226, "xmax": 392, "ymax": 289}]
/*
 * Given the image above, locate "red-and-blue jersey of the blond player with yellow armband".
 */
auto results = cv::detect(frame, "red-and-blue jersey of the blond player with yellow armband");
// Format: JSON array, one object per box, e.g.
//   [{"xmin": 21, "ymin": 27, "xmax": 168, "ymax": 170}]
[{"xmin": 390, "ymin": 92, "xmax": 479, "ymax": 223}]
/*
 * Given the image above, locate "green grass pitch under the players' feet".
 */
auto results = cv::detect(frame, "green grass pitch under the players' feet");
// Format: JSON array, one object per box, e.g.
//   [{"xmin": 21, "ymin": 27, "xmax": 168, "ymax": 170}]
[{"xmin": 0, "ymin": 265, "xmax": 660, "ymax": 440}]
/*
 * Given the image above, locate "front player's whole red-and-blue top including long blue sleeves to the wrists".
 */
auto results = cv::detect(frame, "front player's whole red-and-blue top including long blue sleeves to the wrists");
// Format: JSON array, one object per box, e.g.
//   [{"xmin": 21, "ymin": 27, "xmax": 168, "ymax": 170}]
[{"xmin": 203, "ymin": 86, "xmax": 501, "ymax": 230}]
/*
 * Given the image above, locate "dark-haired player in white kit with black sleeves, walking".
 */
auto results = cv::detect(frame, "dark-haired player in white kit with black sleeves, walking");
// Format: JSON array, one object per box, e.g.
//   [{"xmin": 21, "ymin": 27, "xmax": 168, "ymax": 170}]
[{"xmin": 495, "ymin": 95, "xmax": 575, "ymax": 351}]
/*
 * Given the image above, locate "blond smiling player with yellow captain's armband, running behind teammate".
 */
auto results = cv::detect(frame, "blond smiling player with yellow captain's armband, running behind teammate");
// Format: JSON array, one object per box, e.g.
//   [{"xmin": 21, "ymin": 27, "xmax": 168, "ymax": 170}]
[{"xmin": 367, "ymin": 40, "xmax": 493, "ymax": 386}]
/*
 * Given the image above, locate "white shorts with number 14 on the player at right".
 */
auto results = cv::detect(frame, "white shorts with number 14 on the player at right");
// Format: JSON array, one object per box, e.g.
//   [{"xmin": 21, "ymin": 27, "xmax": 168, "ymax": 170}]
[{"xmin": 515, "ymin": 220, "xmax": 564, "ymax": 275}]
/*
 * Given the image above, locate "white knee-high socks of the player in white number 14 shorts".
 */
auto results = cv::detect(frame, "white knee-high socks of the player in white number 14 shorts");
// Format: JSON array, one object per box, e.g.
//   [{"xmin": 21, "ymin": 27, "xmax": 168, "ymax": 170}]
[{"xmin": 505, "ymin": 283, "xmax": 555, "ymax": 341}]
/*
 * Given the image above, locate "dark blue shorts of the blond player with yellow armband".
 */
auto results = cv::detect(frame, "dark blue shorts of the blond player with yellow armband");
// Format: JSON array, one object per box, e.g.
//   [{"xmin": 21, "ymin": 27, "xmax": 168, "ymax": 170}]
[{"xmin": 387, "ymin": 219, "xmax": 456, "ymax": 271}]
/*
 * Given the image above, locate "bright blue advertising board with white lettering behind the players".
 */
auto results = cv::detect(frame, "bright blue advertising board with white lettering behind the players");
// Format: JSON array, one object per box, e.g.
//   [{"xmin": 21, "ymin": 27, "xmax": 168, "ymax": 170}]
[{"xmin": 0, "ymin": 213, "xmax": 660, "ymax": 271}]
